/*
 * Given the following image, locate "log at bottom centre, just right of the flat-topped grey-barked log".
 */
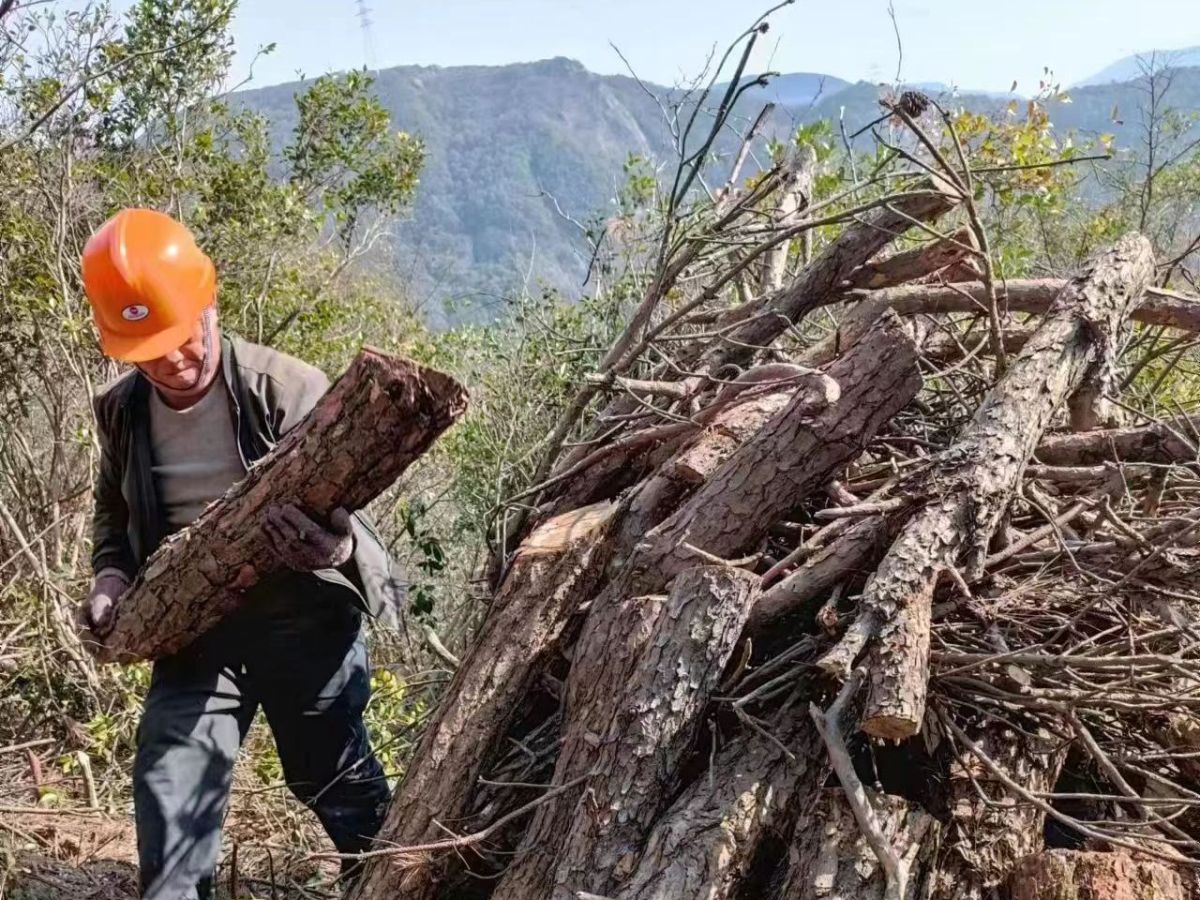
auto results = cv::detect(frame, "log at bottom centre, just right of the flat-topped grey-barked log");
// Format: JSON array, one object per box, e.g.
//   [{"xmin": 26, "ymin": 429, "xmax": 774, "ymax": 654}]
[{"xmin": 611, "ymin": 709, "xmax": 829, "ymax": 900}]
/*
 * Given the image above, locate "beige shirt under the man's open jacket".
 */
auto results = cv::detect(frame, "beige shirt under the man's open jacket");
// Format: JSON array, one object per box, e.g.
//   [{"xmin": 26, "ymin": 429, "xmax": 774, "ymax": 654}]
[{"xmin": 150, "ymin": 376, "xmax": 246, "ymax": 532}]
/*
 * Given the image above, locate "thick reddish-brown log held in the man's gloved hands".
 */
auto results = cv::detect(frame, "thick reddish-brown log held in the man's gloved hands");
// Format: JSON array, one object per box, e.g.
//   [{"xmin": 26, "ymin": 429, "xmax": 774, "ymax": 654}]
[{"xmin": 89, "ymin": 349, "xmax": 467, "ymax": 662}]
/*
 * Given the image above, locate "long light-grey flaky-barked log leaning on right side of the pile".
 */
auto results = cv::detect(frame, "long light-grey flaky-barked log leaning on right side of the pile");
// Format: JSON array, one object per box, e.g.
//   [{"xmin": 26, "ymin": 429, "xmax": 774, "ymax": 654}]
[{"xmin": 821, "ymin": 235, "xmax": 1154, "ymax": 739}]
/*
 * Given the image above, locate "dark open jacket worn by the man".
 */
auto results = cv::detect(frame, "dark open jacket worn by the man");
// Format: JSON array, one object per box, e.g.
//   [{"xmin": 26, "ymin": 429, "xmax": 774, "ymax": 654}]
[{"xmin": 91, "ymin": 337, "xmax": 406, "ymax": 620}]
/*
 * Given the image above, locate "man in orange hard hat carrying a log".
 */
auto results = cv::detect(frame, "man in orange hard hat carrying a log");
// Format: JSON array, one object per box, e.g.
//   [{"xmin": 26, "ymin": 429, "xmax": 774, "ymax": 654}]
[{"xmin": 80, "ymin": 209, "xmax": 403, "ymax": 900}]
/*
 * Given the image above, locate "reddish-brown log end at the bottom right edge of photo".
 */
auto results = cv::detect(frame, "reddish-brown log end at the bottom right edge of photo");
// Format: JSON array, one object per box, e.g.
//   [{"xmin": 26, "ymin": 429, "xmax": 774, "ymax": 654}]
[{"xmin": 1008, "ymin": 850, "xmax": 1192, "ymax": 900}]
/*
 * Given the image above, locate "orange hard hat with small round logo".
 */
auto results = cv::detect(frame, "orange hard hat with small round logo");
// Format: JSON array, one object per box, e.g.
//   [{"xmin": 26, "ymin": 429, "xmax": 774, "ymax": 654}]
[{"xmin": 83, "ymin": 209, "xmax": 217, "ymax": 362}]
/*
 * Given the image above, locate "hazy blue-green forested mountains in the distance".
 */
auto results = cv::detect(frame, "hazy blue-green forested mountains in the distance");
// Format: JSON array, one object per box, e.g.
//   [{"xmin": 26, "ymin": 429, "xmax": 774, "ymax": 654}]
[{"xmin": 236, "ymin": 59, "xmax": 1200, "ymax": 324}]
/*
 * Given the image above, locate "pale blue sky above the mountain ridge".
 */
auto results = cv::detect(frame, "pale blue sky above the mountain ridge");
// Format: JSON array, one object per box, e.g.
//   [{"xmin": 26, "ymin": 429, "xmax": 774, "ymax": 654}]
[{"xmin": 118, "ymin": 0, "xmax": 1200, "ymax": 91}]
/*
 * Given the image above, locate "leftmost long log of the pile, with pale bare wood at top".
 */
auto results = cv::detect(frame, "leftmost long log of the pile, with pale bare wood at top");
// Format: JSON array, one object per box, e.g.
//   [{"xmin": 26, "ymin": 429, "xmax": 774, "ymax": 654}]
[{"xmin": 352, "ymin": 503, "xmax": 617, "ymax": 900}]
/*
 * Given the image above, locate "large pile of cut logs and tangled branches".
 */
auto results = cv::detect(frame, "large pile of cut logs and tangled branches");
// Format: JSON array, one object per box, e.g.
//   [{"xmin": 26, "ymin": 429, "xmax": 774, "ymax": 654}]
[{"xmin": 354, "ymin": 65, "xmax": 1200, "ymax": 900}]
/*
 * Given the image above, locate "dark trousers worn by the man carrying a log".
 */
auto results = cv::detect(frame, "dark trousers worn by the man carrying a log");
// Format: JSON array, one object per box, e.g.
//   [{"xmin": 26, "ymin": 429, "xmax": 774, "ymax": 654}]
[{"xmin": 133, "ymin": 575, "xmax": 389, "ymax": 900}]
